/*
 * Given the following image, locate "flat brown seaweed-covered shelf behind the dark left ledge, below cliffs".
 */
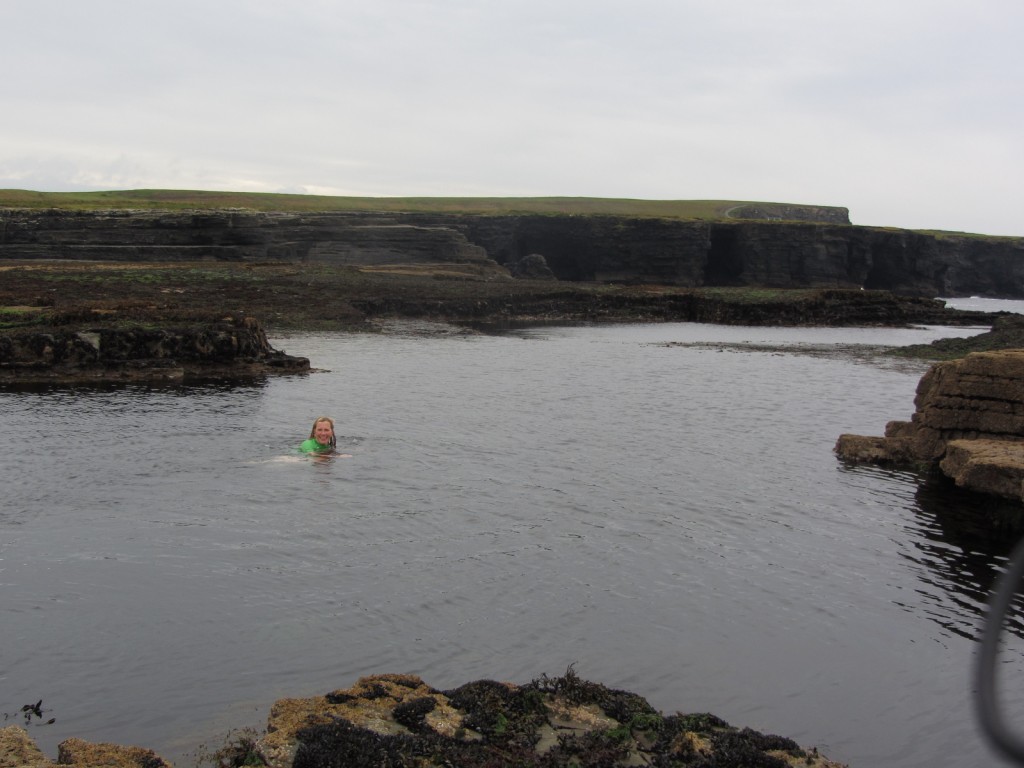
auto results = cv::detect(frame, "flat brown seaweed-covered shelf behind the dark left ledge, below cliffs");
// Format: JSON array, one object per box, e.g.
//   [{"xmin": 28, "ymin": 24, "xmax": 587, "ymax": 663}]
[{"xmin": 0, "ymin": 261, "xmax": 993, "ymax": 331}]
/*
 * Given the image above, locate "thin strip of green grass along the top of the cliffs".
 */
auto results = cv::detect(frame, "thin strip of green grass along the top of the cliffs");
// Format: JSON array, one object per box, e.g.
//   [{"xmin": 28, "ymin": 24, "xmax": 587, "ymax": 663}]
[{"xmin": 0, "ymin": 189, "xmax": 811, "ymax": 219}]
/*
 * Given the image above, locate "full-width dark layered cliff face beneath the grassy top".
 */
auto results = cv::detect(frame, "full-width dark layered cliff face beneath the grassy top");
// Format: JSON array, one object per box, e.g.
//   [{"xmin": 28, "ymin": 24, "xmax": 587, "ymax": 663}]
[{"xmin": 0, "ymin": 210, "xmax": 1024, "ymax": 298}]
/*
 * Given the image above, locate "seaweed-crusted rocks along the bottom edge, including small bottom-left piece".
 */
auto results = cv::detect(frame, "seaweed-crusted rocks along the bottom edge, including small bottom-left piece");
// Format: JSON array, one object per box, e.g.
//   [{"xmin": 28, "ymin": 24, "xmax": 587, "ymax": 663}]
[{"xmin": 0, "ymin": 669, "xmax": 842, "ymax": 768}]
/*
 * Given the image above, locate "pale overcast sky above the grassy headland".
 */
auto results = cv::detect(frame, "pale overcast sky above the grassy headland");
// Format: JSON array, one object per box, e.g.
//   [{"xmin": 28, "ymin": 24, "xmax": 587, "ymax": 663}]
[{"xmin": 0, "ymin": 0, "xmax": 1024, "ymax": 236}]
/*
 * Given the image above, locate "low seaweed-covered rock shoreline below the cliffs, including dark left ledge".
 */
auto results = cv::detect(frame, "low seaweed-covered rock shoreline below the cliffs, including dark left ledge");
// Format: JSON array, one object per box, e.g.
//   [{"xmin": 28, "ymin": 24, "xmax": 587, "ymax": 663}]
[{"xmin": 0, "ymin": 262, "xmax": 995, "ymax": 384}]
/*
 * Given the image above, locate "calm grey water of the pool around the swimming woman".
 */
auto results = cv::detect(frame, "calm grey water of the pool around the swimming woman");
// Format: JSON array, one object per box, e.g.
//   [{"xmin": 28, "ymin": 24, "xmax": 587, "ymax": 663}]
[{"xmin": 0, "ymin": 313, "xmax": 1024, "ymax": 768}]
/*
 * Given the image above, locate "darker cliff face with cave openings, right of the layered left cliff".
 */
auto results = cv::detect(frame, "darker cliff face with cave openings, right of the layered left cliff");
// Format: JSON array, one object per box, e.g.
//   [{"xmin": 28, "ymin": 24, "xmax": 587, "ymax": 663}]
[{"xmin": 461, "ymin": 216, "xmax": 1024, "ymax": 298}]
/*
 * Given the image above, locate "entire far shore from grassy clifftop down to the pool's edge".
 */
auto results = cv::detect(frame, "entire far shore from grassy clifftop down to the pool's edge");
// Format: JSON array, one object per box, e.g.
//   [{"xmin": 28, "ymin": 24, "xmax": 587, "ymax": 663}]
[{"xmin": 0, "ymin": 189, "xmax": 1024, "ymax": 381}]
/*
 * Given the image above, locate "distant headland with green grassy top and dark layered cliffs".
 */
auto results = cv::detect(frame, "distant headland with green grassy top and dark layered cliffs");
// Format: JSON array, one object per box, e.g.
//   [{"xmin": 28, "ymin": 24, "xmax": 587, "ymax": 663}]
[{"xmin": 0, "ymin": 189, "xmax": 1024, "ymax": 298}]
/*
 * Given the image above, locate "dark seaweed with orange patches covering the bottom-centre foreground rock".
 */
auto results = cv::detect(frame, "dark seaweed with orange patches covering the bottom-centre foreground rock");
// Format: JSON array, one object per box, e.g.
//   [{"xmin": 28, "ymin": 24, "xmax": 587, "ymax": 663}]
[{"xmin": 284, "ymin": 667, "xmax": 838, "ymax": 768}]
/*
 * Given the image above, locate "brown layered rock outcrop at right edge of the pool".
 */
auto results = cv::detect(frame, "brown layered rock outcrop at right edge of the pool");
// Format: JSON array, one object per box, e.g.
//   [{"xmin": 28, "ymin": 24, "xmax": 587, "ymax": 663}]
[{"xmin": 836, "ymin": 349, "xmax": 1024, "ymax": 502}]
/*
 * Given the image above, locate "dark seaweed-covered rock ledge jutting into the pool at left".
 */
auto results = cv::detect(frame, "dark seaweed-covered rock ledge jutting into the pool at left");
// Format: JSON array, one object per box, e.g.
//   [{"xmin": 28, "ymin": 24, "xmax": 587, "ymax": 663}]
[{"xmin": 0, "ymin": 317, "xmax": 309, "ymax": 384}]
